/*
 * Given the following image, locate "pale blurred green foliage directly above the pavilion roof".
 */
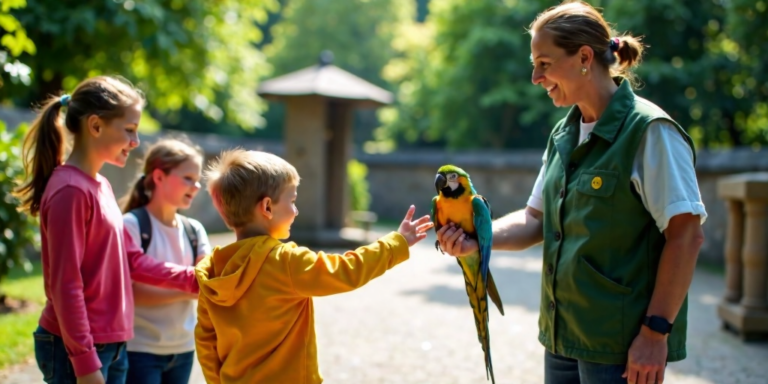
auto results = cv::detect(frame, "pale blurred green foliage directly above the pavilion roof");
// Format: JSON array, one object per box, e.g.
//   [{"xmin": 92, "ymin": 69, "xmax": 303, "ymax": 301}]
[{"xmin": 264, "ymin": 0, "xmax": 415, "ymax": 87}]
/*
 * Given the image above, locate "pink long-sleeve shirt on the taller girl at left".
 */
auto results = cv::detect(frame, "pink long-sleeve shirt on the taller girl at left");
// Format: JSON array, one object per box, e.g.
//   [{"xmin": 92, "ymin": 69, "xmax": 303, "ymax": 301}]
[{"xmin": 40, "ymin": 165, "xmax": 198, "ymax": 377}]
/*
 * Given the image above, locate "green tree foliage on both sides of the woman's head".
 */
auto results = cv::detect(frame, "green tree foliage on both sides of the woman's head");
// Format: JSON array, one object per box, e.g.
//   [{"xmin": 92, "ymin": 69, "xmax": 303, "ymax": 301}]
[{"xmin": 384, "ymin": 0, "xmax": 768, "ymax": 149}]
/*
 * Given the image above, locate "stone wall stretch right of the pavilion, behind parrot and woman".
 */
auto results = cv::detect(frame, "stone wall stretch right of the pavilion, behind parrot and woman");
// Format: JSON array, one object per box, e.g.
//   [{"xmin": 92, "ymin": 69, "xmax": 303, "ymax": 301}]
[{"xmin": 358, "ymin": 148, "xmax": 768, "ymax": 264}]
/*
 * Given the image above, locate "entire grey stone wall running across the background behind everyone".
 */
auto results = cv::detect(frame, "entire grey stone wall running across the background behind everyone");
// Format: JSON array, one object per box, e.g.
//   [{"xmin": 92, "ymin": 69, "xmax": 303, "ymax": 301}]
[{"xmin": 0, "ymin": 108, "xmax": 768, "ymax": 264}]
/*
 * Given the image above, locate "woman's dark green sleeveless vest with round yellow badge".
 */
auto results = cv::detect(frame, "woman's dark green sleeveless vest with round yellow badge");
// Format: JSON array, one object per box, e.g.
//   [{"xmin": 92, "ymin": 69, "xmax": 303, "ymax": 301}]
[{"xmin": 539, "ymin": 81, "xmax": 695, "ymax": 364}]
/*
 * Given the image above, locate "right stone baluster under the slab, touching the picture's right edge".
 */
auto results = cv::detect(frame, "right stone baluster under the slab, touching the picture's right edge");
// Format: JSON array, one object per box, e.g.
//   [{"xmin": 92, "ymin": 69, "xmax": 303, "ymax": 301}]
[{"xmin": 741, "ymin": 199, "xmax": 768, "ymax": 309}]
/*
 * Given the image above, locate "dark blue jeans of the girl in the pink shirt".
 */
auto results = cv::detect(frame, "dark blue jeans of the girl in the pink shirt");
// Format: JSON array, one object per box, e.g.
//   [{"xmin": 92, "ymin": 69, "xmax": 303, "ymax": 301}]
[{"xmin": 32, "ymin": 326, "xmax": 128, "ymax": 384}]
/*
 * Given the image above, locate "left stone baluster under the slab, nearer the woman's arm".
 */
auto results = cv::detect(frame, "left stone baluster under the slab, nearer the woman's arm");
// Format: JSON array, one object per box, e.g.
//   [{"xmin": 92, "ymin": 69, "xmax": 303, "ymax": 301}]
[{"xmin": 725, "ymin": 200, "xmax": 744, "ymax": 303}]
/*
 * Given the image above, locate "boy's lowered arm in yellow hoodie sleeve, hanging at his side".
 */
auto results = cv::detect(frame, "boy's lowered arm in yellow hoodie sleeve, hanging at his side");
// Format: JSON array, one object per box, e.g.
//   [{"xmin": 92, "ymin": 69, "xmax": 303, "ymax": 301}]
[{"xmin": 195, "ymin": 295, "xmax": 221, "ymax": 384}]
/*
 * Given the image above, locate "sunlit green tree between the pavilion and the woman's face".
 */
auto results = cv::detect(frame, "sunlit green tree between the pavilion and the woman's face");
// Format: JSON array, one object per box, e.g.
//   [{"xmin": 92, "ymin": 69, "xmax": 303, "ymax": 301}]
[{"xmin": 378, "ymin": 0, "xmax": 564, "ymax": 148}]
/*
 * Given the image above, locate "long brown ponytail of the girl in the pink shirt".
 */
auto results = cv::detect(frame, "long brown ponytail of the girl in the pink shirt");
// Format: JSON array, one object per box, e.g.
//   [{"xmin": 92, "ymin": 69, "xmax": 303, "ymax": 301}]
[{"xmin": 13, "ymin": 95, "xmax": 68, "ymax": 216}]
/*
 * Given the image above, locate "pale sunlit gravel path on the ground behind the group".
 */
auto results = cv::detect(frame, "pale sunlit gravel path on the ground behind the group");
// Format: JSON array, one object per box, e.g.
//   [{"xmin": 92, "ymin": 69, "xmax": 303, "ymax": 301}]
[{"xmin": 0, "ymin": 230, "xmax": 768, "ymax": 384}]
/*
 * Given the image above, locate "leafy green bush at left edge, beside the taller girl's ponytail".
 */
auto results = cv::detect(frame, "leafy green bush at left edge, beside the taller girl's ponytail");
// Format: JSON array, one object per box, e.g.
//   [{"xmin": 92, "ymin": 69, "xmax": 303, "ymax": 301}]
[{"xmin": 0, "ymin": 121, "xmax": 39, "ymax": 281}]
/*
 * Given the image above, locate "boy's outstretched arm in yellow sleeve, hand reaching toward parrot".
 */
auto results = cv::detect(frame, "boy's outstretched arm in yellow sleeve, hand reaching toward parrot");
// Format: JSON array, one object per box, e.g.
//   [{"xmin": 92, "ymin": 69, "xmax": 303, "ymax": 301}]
[{"xmin": 288, "ymin": 206, "xmax": 432, "ymax": 296}]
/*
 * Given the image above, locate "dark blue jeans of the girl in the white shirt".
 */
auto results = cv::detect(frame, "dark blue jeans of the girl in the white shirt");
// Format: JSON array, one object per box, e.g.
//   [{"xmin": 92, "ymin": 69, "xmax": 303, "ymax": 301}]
[{"xmin": 128, "ymin": 351, "xmax": 195, "ymax": 384}]
